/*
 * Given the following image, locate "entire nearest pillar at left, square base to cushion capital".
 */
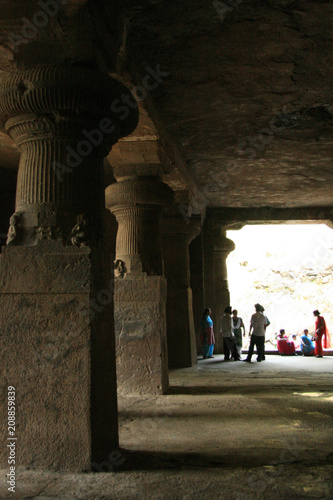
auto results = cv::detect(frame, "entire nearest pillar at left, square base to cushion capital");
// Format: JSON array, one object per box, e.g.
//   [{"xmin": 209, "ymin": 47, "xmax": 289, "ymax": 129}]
[{"xmin": 0, "ymin": 66, "xmax": 137, "ymax": 471}]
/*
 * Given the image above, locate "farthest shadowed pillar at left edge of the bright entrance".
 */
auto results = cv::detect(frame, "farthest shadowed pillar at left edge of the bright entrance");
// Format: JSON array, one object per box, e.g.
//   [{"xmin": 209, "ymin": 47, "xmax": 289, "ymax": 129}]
[{"xmin": 203, "ymin": 209, "xmax": 235, "ymax": 353}]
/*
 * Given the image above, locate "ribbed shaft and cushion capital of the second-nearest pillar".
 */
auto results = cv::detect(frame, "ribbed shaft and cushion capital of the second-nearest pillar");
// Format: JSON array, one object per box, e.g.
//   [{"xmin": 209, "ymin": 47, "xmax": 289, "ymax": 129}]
[{"xmin": 105, "ymin": 177, "xmax": 173, "ymax": 275}]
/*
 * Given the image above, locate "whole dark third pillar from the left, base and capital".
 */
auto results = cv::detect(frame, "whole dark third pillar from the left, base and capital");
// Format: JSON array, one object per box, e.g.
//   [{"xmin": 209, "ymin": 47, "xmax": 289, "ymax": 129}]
[{"xmin": 161, "ymin": 211, "xmax": 201, "ymax": 368}]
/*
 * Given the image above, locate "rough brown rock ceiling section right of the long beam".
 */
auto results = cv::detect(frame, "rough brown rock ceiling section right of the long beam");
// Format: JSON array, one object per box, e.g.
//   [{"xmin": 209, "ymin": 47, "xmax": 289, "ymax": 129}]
[{"xmin": 117, "ymin": 0, "xmax": 333, "ymax": 207}]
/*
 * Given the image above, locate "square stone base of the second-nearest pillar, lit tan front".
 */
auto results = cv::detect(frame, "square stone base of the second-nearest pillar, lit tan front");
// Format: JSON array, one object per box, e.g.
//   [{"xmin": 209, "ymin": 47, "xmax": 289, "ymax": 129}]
[{"xmin": 114, "ymin": 273, "xmax": 169, "ymax": 394}]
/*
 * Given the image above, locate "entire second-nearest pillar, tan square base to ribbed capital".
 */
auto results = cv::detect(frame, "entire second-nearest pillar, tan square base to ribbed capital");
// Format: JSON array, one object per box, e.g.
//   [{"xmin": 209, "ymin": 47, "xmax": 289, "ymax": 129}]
[{"xmin": 106, "ymin": 172, "xmax": 173, "ymax": 394}]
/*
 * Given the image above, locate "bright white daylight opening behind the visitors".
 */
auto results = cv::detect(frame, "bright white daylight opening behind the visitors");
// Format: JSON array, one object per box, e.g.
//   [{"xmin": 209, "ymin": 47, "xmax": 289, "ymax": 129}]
[{"xmin": 227, "ymin": 224, "xmax": 333, "ymax": 349}]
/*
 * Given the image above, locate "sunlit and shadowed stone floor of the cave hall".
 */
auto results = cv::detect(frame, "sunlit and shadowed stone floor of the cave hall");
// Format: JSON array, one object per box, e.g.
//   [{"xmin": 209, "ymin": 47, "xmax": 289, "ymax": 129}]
[{"xmin": 0, "ymin": 355, "xmax": 333, "ymax": 500}]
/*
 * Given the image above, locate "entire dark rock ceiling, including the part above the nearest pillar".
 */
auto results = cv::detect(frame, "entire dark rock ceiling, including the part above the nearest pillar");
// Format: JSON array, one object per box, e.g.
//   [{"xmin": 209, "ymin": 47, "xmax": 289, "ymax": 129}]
[{"xmin": 0, "ymin": 0, "xmax": 333, "ymax": 211}]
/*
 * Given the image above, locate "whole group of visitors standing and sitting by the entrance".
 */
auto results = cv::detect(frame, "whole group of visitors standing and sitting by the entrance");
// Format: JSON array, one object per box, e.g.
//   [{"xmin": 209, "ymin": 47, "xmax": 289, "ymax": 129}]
[{"xmin": 200, "ymin": 304, "xmax": 329, "ymax": 363}]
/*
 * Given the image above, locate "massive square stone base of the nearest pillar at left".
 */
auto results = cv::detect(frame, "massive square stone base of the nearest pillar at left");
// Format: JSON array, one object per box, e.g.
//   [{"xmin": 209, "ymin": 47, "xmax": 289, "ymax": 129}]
[{"xmin": 0, "ymin": 241, "xmax": 118, "ymax": 471}]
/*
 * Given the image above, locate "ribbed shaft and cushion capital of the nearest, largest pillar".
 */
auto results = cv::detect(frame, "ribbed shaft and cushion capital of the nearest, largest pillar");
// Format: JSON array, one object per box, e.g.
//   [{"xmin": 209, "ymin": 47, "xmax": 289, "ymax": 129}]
[{"xmin": 0, "ymin": 66, "xmax": 137, "ymax": 246}]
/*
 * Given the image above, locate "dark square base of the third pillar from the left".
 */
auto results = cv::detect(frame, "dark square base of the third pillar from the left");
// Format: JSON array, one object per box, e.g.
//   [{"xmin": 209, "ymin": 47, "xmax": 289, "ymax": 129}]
[{"xmin": 167, "ymin": 287, "xmax": 200, "ymax": 368}]
